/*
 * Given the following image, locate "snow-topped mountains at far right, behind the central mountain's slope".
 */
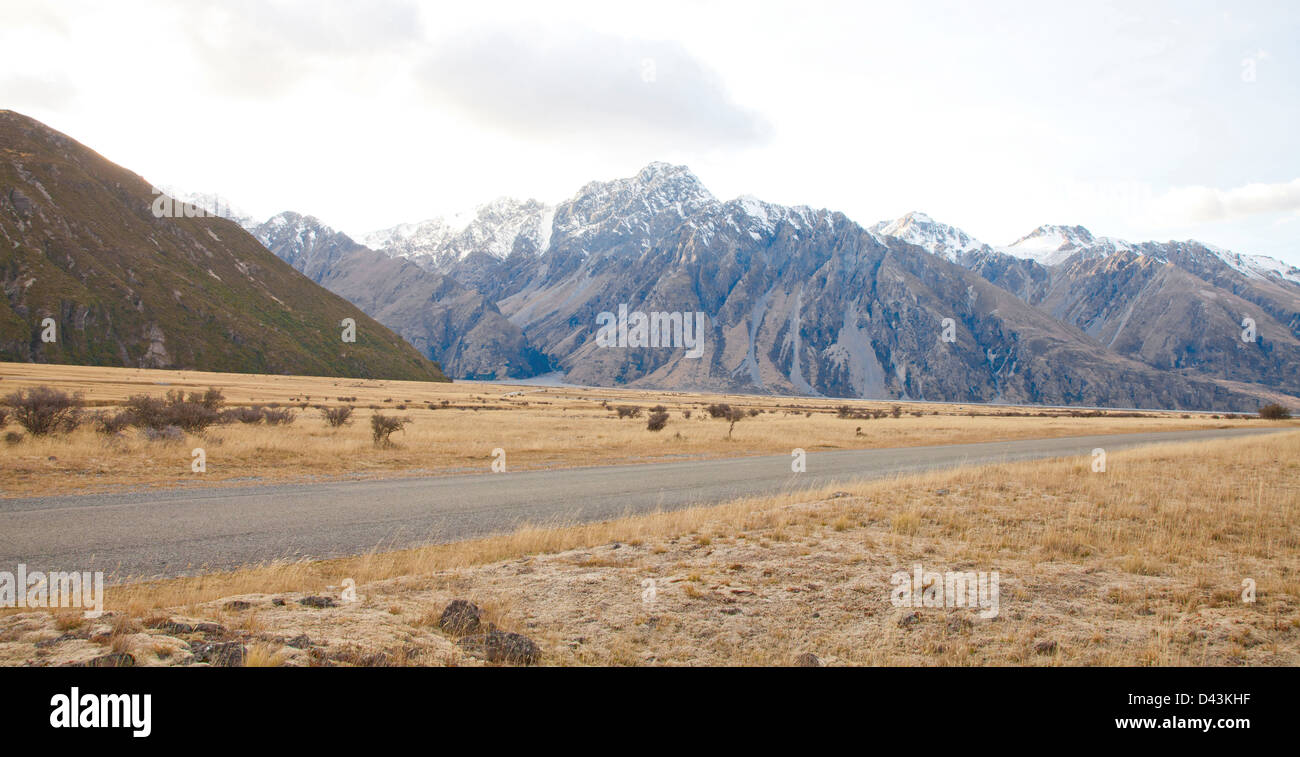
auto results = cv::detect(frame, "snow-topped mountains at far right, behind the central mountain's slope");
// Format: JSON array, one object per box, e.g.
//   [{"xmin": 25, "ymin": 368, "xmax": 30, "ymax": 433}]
[{"xmin": 876, "ymin": 216, "xmax": 1300, "ymax": 394}]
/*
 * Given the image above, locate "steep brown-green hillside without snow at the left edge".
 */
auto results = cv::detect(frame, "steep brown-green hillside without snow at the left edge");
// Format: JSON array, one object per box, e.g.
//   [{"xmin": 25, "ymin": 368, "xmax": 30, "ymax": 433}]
[{"xmin": 0, "ymin": 111, "xmax": 446, "ymax": 381}]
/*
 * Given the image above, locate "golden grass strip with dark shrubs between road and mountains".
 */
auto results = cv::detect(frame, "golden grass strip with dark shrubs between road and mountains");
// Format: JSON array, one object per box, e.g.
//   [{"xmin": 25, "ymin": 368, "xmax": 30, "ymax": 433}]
[{"xmin": 0, "ymin": 363, "xmax": 1295, "ymax": 497}]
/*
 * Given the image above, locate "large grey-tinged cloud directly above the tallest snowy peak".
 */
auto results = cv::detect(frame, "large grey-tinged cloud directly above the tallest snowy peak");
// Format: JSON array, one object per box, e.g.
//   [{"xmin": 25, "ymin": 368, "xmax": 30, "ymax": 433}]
[{"xmin": 416, "ymin": 26, "xmax": 768, "ymax": 148}]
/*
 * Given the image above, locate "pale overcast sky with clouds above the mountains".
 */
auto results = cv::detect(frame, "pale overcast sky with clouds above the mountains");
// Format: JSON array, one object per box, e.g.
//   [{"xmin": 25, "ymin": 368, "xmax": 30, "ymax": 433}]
[{"xmin": 0, "ymin": 0, "xmax": 1300, "ymax": 265}]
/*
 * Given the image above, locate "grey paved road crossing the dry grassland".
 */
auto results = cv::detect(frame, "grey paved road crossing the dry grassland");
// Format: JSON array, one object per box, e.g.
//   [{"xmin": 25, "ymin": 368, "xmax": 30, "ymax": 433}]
[{"xmin": 0, "ymin": 429, "xmax": 1268, "ymax": 580}]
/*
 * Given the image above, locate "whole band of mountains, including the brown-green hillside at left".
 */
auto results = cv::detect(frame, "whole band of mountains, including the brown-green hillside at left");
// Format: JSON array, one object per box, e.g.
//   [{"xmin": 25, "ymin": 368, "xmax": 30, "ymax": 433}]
[{"xmin": 0, "ymin": 112, "xmax": 1300, "ymax": 411}]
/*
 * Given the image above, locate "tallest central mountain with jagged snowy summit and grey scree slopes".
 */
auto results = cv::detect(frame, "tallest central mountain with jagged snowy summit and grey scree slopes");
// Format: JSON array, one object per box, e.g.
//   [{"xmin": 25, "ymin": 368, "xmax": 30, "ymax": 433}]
[{"xmin": 439, "ymin": 164, "xmax": 1279, "ymax": 407}]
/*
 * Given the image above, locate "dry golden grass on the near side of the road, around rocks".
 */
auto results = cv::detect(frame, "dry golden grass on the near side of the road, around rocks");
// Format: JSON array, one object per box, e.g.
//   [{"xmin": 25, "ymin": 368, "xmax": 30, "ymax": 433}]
[{"xmin": 0, "ymin": 433, "xmax": 1300, "ymax": 665}]
